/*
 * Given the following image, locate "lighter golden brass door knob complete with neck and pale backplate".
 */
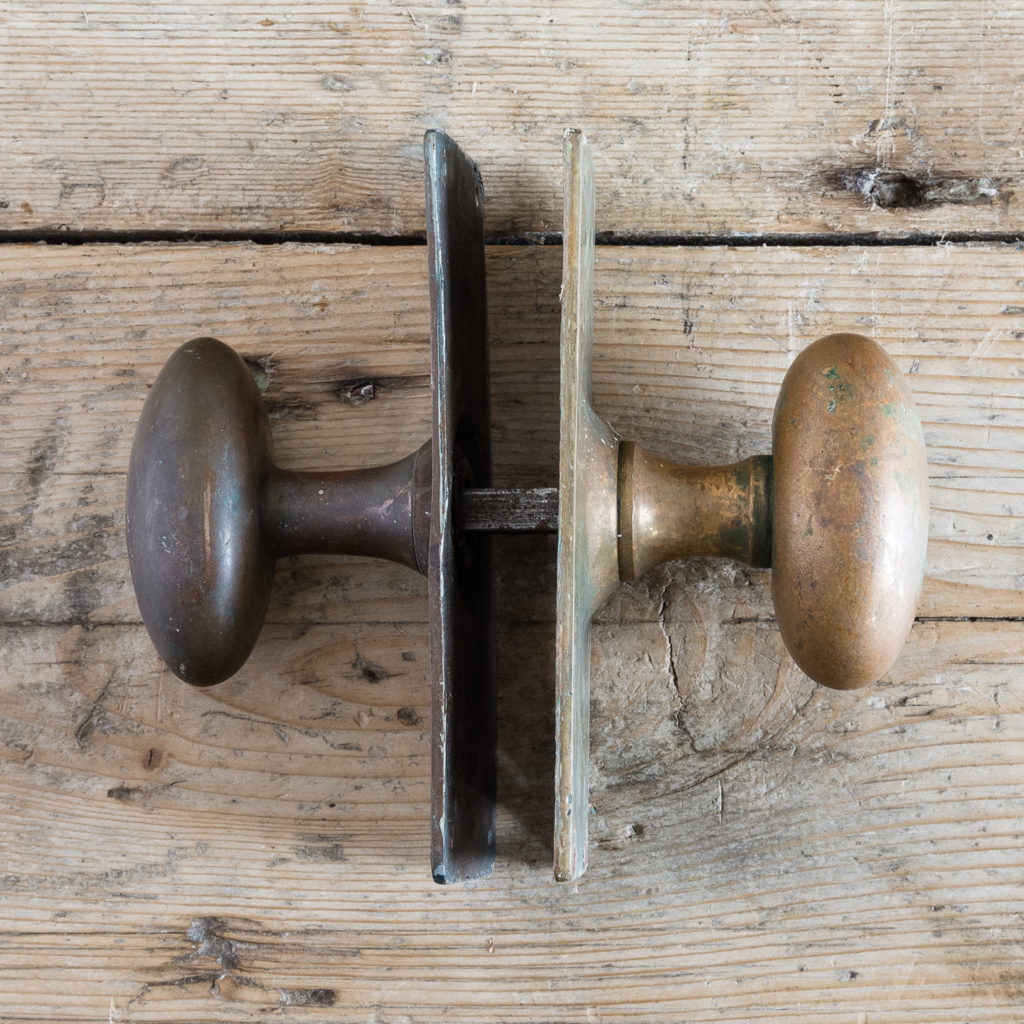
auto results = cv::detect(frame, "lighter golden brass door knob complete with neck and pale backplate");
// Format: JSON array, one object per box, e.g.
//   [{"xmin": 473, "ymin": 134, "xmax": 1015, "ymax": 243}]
[{"xmin": 555, "ymin": 132, "xmax": 928, "ymax": 881}]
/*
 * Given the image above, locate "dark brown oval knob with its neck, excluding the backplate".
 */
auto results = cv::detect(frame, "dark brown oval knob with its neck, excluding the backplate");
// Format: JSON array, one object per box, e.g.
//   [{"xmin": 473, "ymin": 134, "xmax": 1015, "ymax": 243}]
[{"xmin": 125, "ymin": 338, "xmax": 430, "ymax": 686}]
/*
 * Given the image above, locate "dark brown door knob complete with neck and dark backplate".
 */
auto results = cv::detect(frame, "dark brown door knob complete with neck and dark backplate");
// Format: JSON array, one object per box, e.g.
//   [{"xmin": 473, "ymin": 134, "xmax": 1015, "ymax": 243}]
[{"xmin": 126, "ymin": 132, "xmax": 497, "ymax": 882}]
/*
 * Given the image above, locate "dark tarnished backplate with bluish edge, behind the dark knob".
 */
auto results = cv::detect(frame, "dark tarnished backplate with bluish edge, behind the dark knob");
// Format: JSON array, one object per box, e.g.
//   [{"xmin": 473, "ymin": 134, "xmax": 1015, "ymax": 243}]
[{"xmin": 424, "ymin": 125, "xmax": 497, "ymax": 883}]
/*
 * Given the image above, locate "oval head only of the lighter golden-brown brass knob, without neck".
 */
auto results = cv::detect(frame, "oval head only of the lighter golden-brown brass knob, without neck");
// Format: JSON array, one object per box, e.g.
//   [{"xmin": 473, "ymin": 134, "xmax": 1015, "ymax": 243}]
[{"xmin": 772, "ymin": 334, "xmax": 928, "ymax": 689}]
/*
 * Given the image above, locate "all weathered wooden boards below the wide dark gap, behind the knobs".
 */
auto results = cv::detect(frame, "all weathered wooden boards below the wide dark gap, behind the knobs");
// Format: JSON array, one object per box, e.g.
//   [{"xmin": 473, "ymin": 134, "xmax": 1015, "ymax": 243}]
[{"xmin": 0, "ymin": 243, "xmax": 1024, "ymax": 1024}]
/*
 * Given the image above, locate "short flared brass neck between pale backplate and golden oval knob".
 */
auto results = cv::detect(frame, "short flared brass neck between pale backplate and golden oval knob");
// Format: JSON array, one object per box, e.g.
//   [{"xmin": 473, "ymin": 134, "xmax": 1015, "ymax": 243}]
[{"xmin": 618, "ymin": 441, "xmax": 772, "ymax": 580}]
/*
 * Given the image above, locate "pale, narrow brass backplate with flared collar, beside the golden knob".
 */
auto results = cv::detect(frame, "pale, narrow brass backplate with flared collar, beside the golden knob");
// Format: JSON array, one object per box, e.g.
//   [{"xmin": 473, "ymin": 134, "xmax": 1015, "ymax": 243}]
[{"xmin": 554, "ymin": 125, "xmax": 618, "ymax": 881}]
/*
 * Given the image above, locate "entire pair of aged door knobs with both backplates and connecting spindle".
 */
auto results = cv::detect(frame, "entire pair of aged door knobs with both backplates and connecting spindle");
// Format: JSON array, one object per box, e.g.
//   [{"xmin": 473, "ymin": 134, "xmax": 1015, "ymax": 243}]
[{"xmin": 126, "ymin": 132, "xmax": 928, "ymax": 882}]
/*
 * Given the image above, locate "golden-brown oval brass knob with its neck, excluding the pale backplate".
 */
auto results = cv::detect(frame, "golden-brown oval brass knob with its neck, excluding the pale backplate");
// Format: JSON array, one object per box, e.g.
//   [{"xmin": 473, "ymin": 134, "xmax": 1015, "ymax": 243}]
[{"xmin": 618, "ymin": 334, "xmax": 928, "ymax": 689}]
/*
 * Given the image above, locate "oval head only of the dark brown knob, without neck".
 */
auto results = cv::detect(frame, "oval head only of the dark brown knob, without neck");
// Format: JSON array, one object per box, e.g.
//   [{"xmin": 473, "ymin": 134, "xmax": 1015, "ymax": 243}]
[{"xmin": 125, "ymin": 338, "xmax": 274, "ymax": 686}]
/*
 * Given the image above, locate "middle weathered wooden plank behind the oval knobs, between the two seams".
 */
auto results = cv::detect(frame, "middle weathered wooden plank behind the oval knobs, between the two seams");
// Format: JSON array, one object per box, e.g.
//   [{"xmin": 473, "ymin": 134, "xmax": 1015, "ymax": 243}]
[{"xmin": 0, "ymin": 246, "xmax": 1024, "ymax": 622}]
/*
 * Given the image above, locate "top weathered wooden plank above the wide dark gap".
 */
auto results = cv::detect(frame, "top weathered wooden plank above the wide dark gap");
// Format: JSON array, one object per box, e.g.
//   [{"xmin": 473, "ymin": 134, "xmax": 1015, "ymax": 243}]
[{"xmin": 6, "ymin": 0, "xmax": 1024, "ymax": 236}]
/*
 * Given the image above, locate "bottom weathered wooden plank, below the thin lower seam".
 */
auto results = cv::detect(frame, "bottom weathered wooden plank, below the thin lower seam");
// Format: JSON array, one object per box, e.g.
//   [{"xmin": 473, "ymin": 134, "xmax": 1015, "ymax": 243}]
[{"xmin": 0, "ymin": 614, "xmax": 1024, "ymax": 1022}]
